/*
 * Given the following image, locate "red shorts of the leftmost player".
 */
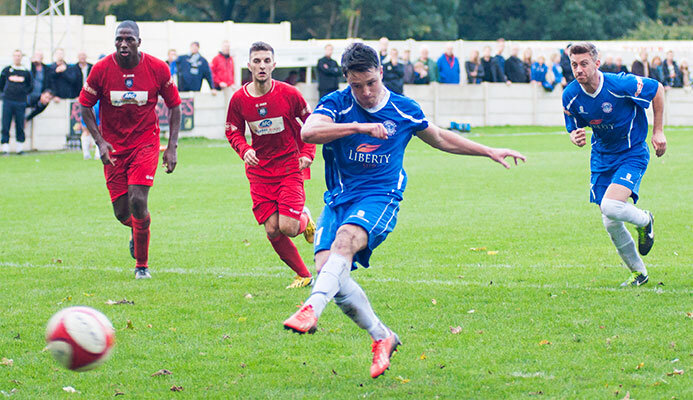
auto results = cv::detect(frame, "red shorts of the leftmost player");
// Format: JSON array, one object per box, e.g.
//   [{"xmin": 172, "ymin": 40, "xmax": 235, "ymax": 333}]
[{"xmin": 103, "ymin": 144, "xmax": 159, "ymax": 202}]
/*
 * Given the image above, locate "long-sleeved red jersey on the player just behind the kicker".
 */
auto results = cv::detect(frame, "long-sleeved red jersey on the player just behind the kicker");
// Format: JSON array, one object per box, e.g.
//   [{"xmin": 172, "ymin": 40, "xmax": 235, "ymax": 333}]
[{"xmin": 226, "ymin": 80, "xmax": 315, "ymax": 183}]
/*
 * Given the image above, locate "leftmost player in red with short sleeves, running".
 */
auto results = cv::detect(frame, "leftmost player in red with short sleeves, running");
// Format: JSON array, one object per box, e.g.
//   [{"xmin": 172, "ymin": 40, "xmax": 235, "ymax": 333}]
[{"xmin": 79, "ymin": 21, "xmax": 181, "ymax": 279}]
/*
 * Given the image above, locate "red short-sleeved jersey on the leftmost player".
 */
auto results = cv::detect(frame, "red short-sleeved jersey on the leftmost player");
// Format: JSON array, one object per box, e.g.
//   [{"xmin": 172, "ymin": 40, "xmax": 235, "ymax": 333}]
[{"xmin": 79, "ymin": 53, "xmax": 180, "ymax": 154}]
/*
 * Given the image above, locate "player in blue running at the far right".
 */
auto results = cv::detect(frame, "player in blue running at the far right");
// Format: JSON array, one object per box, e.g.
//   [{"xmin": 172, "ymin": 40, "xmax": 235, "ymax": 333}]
[{"xmin": 563, "ymin": 42, "xmax": 667, "ymax": 286}]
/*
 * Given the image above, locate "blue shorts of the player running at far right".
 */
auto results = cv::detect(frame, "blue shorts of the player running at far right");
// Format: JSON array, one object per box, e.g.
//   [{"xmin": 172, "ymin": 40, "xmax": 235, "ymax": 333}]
[{"xmin": 590, "ymin": 143, "xmax": 650, "ymax": 204}]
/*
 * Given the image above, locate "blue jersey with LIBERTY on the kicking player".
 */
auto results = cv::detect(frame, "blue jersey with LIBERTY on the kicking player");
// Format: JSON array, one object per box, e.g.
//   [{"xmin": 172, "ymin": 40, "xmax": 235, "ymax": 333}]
[{"xmin": 313, "ymin": 86, "xmax": 428, "ymax": 206}]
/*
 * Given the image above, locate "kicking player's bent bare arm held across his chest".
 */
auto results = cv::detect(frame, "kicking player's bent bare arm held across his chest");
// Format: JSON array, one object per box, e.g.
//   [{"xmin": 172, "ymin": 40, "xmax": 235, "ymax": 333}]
[{"xmin": 301, "ymin": 113, "xmax": 387, "ymax": 144}]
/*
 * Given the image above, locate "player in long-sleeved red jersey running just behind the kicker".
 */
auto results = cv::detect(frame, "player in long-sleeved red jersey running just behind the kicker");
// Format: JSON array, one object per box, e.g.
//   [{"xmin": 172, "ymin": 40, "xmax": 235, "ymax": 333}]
[{"xmin": 226, "ymin": 42, "xmax": 315, "ymax": 289}]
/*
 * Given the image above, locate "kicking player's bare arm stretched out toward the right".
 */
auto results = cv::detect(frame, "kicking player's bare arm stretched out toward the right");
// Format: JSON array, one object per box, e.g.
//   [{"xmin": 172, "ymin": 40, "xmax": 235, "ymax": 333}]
[{"xmin": 417, "ymin": 124, "xmax": 526, "ymax": 168}]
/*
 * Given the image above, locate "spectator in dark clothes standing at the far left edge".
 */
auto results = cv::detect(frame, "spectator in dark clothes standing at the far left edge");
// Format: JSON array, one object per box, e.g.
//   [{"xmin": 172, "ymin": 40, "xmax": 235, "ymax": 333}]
[{"xmin": 0, "ymin": 50, "xmax": 33, "ymax": 155}]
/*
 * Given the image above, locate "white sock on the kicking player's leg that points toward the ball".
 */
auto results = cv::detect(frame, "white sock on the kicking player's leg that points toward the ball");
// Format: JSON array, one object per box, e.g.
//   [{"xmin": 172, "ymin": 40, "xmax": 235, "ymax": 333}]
[{"xmin": 305, "ymin": 253, "xmax": 351, "ymax": 318}]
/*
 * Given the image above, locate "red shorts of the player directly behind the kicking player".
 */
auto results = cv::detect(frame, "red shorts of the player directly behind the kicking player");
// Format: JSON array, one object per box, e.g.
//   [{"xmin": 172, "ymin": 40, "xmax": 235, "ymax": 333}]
[{"xmin": 250, "ymin": 171, "xmax": 306, "ymax": 224}]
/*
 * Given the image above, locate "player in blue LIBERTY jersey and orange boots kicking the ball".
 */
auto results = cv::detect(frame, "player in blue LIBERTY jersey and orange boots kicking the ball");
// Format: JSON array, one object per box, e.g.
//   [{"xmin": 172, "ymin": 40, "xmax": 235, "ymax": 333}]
[{"xmin": 284, "ymin": 43, "xmax": 525, "ymax": 378}]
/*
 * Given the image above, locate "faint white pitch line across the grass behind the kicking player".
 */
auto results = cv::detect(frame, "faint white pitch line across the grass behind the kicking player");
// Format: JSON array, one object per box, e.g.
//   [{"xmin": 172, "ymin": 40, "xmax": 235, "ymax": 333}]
[{"xmin": 0, "ymin": 262, "xmax": 693, "ymax": 294}]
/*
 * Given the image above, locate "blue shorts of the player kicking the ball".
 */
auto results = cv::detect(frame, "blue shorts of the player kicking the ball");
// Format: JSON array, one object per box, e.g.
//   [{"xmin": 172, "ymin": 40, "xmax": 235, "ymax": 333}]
[{"xmin": 314, "ymin": 196, "xmax": 399, "ymax": 269}]
